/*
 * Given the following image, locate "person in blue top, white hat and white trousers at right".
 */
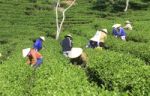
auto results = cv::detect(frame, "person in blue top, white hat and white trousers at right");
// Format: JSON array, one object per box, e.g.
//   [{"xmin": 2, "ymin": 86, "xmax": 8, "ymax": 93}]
[{"xmin": 112, "ymin": 24, "xmax": 126, "ymax": 41}]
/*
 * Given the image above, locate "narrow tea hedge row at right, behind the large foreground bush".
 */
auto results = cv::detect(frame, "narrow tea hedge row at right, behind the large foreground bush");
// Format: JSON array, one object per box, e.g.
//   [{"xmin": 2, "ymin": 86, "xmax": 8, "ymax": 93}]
[{"xmin": 107, "ymin": 38, "xmax": 150, "ymax": 65}]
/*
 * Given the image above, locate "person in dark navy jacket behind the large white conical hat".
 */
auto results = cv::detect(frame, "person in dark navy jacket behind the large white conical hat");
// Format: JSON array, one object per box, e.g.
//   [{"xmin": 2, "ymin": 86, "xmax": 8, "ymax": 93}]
[{"xmin": 61, "ymin": 34, "xmax": 73, "ymax": 57}]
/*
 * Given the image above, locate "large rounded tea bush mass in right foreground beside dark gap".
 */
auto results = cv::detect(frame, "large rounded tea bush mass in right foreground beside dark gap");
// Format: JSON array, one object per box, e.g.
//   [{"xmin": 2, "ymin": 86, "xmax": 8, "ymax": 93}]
[{"xmin": 88, "ymin": 50, "xmax": 150, "ymax": 96}]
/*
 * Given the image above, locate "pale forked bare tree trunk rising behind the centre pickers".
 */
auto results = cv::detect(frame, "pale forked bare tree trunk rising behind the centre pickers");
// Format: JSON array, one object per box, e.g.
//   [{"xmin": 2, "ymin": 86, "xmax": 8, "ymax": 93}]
[{"xmin": 56, "ymin": 0, "xmax": 76, "ymax": 40}]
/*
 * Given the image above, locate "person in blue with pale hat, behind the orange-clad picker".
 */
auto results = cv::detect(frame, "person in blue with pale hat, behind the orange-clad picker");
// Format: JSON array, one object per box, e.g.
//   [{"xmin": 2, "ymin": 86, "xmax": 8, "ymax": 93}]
[{"xmin": 33, "ymin": 36, "xmax": 45, "ymax": 51}]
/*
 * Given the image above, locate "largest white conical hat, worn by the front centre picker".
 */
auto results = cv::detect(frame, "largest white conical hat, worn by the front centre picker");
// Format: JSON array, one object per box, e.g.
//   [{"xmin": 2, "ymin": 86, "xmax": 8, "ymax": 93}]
[{"xmin": 68, "ymin": 48, "xmax": 83, "ymax": 58}]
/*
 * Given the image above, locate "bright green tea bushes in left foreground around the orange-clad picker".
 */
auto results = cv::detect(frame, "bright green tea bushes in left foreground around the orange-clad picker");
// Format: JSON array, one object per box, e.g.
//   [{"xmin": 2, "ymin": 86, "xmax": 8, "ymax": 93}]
[{"xmin": 0, "ymin": 38, "xmax": 125, "ymax": 96}]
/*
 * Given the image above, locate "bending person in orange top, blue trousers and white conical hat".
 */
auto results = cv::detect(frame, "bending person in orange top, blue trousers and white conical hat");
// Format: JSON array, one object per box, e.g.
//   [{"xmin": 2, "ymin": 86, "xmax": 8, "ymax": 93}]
[{"xmin": 22, "ymin": 48, "xmax": 43, "ymax": 68}]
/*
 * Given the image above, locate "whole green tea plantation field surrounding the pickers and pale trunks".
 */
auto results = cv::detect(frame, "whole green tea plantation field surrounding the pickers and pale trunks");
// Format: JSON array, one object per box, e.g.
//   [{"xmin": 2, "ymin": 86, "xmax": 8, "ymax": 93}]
[{"xmin": 0, "ymin": 0, "xmax": 150, "ymax": 96}]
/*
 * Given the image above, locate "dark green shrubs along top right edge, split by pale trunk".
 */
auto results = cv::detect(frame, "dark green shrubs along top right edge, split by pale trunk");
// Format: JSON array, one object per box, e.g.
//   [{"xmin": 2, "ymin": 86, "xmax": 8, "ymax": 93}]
[{"xmin": 93, "ymin": 0, "xmax": 149, "ymax": 12}]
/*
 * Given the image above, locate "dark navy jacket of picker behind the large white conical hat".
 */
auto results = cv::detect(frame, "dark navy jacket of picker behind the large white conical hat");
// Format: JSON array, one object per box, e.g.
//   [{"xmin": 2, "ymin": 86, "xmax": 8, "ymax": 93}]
[{"xmin": 61, "ymin": 37, "xmax": 73, "ymax": 51}]
